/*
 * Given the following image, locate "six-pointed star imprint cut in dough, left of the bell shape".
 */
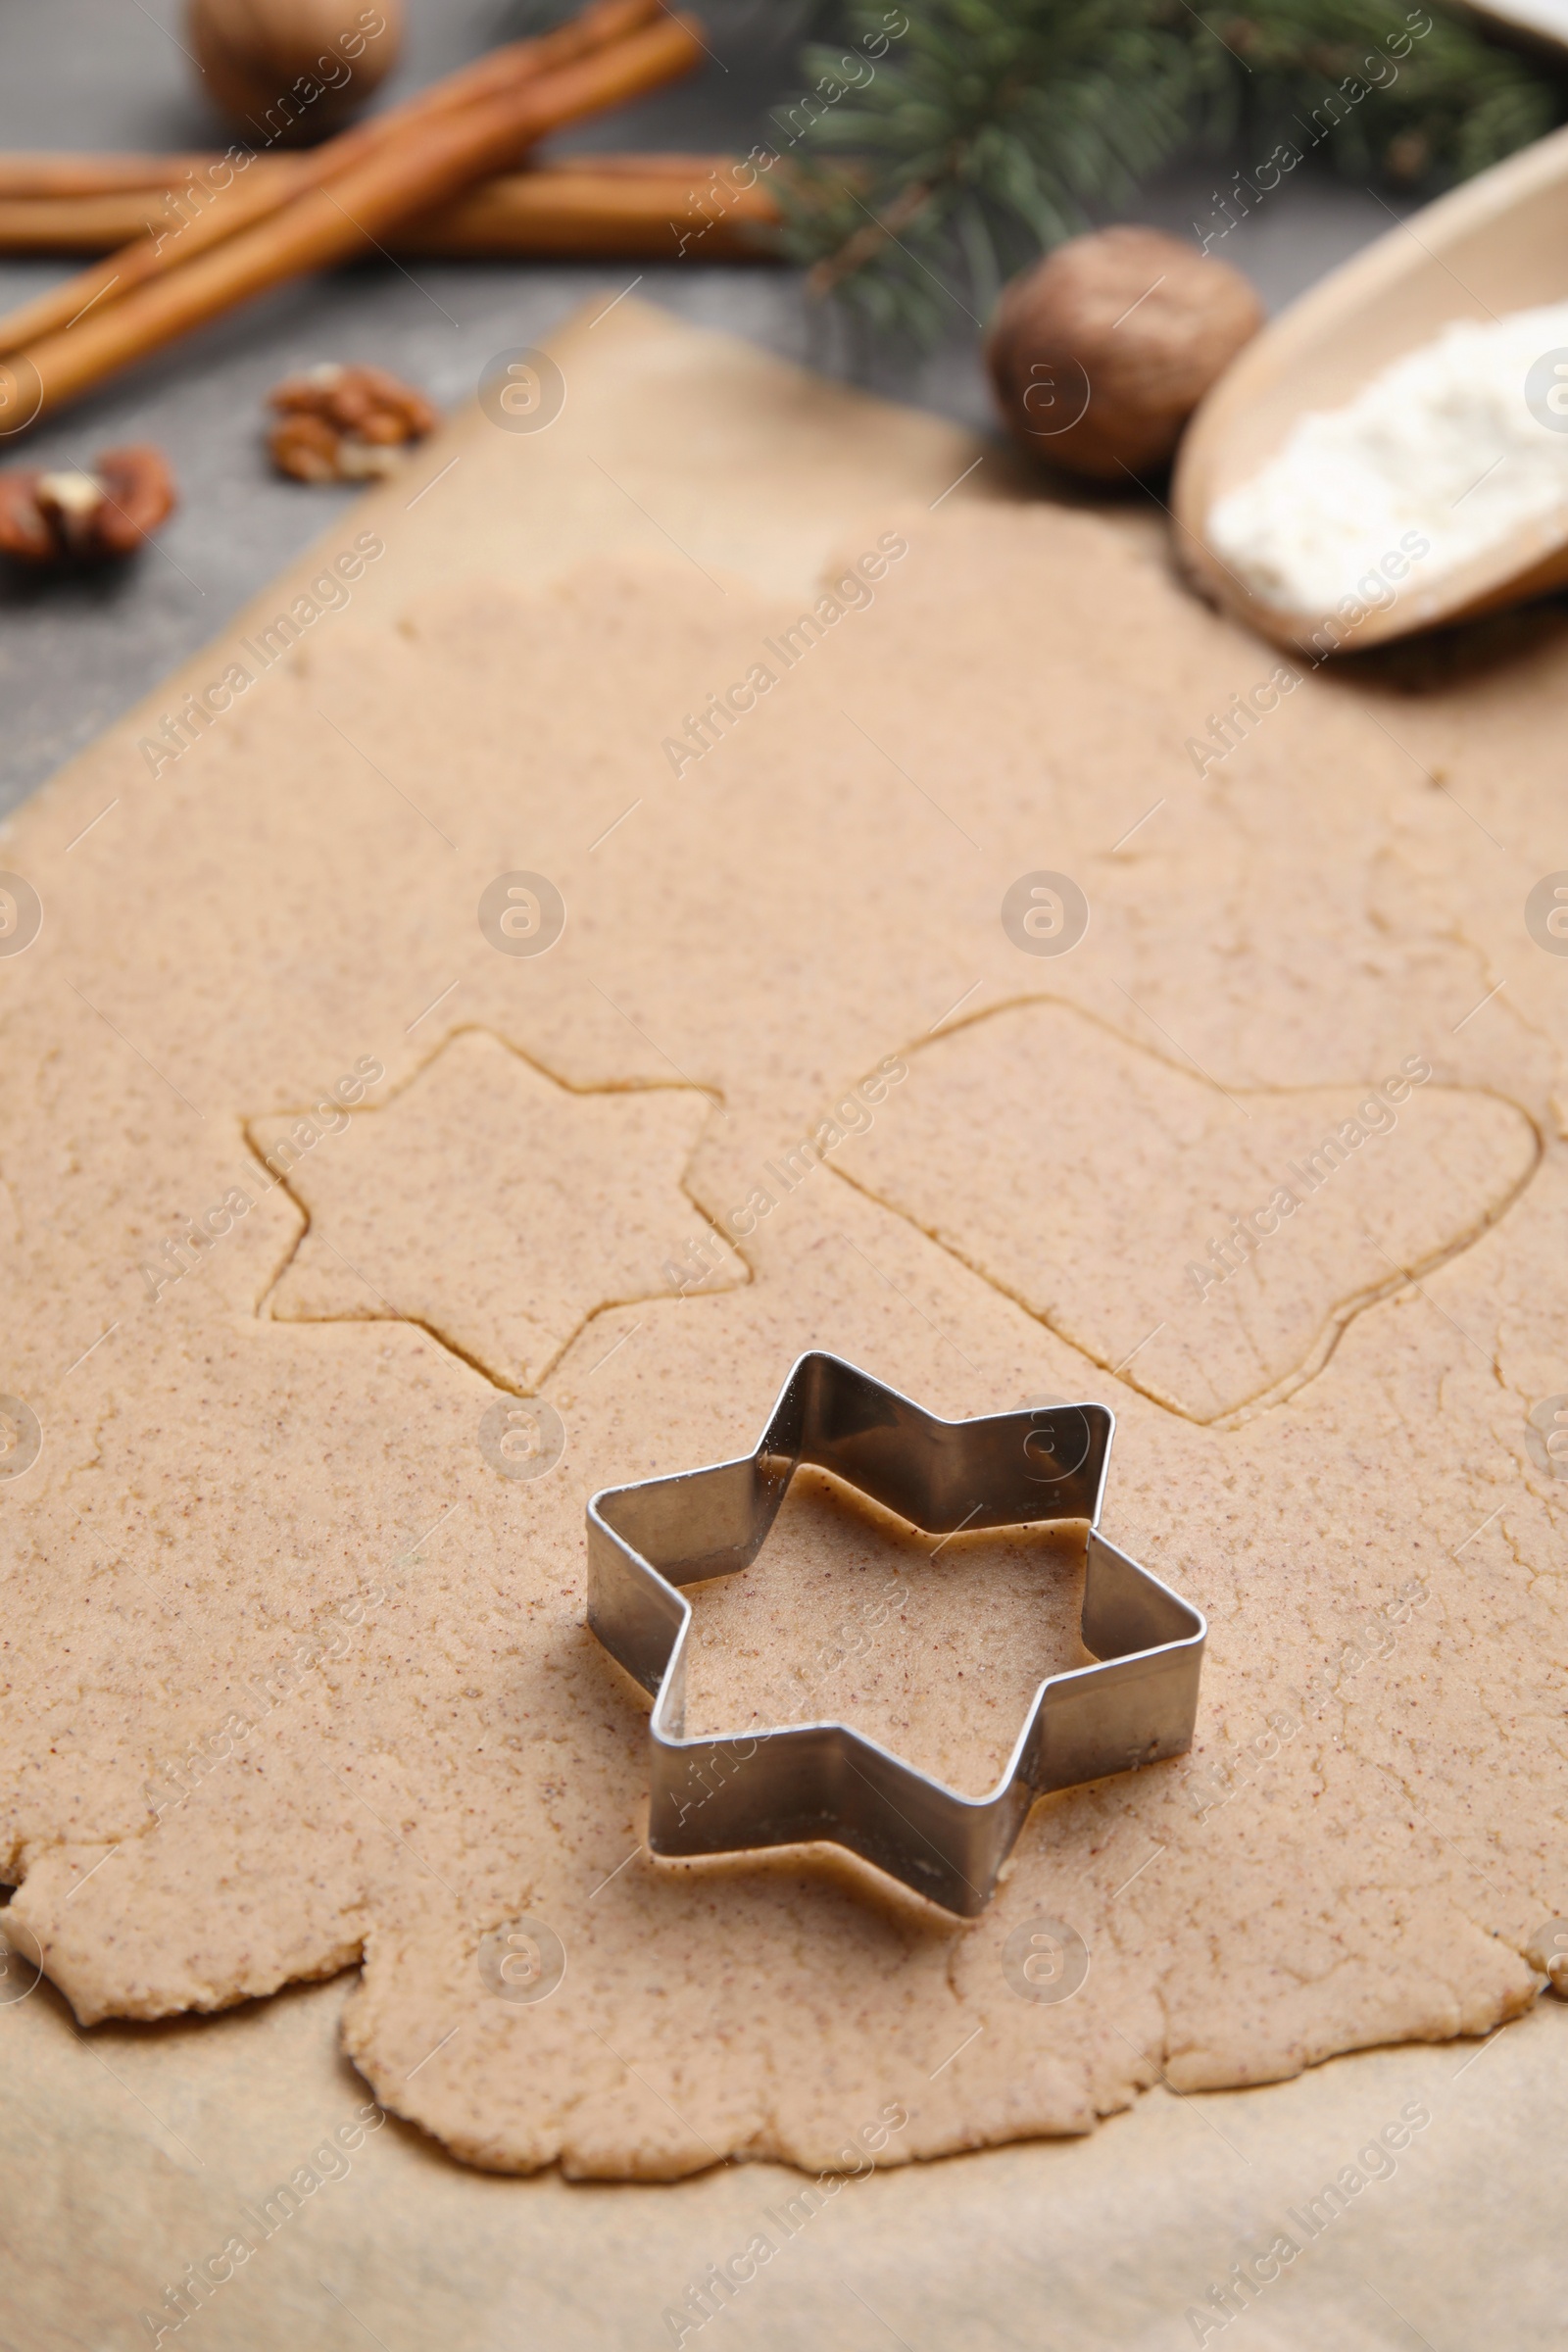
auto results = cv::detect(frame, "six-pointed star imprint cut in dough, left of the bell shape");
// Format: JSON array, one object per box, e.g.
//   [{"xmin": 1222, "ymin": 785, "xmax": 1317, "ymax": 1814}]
[{"xmin": 249, "ymin": 1030, "xmax": 745, "ymax": 1393}]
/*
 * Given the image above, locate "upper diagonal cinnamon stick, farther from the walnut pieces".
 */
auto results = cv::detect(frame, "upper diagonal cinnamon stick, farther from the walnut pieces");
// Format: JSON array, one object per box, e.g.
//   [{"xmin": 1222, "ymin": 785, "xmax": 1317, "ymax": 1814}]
[{"xmin": 0, "ymin": 0, "xmax": 659, "ymax": 351}]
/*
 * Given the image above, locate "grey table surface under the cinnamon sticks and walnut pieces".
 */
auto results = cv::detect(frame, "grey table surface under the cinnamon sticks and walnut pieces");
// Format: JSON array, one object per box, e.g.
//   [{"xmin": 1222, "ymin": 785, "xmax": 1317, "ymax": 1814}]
[{"xmin": 0, "ymin": 0, "xmax": 1419, "ymax": 813}]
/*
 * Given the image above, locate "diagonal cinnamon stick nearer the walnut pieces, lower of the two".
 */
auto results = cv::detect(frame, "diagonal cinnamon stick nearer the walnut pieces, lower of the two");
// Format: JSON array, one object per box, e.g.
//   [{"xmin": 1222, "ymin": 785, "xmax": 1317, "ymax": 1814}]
[{"xmin": 0, "ymin": 17, "xmax": 703, "ymax": 428}]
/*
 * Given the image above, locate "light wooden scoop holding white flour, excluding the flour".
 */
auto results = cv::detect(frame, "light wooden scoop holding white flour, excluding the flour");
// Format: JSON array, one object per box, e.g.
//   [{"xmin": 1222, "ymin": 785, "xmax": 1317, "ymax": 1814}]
[{"xmin": 1171, "ymin": 129, "xmax": 1568, "ymax": 654}]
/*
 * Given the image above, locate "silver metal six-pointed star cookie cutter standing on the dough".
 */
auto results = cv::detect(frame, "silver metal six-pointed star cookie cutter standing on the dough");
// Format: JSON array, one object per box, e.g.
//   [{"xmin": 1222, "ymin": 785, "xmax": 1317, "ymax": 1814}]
[{"xmin": 588, "ymin": 1352, "xmax": 1208, "ymax": 1917}]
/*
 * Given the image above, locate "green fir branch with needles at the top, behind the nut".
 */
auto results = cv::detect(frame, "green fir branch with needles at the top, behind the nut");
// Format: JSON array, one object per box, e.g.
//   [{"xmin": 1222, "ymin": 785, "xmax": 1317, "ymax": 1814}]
[{"xmin": 773, "ymin": 0, "xmax": 1568, "ymax": 341}]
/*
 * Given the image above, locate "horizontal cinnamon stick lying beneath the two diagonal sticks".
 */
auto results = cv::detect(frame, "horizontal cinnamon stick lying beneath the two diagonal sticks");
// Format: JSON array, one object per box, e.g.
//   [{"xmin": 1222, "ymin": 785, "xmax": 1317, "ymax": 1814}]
[{"xmin": 0, "ymin": 155, "xmax": 778, "ymax": 261}]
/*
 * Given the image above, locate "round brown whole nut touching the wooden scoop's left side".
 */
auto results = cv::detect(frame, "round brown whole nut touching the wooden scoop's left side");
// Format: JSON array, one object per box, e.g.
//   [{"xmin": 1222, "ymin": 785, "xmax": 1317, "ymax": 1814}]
[{"xmin": 985, "ymin": 228, "xmax": 1262, "ymax": 482}]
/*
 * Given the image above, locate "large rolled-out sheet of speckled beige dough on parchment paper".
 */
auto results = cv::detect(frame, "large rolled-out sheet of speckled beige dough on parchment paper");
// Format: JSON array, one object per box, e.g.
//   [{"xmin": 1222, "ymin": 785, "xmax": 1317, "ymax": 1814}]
[{"xmin": 0, "ymin": 437, "xmax": 1568, "ymax": 2178}]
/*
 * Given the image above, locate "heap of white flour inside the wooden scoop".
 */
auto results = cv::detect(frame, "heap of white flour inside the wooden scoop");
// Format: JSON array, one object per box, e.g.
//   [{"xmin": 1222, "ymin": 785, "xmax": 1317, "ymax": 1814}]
[{"xmin": 1208, "ymin": 304, "xmax": 1568, "ymax": 613}]
